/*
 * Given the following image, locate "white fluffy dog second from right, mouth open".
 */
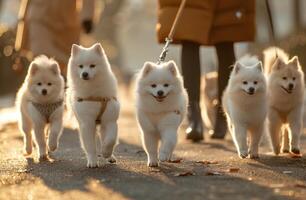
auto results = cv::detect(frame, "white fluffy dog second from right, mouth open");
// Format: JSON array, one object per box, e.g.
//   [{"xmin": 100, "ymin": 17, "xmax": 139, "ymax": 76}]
[{"xmin": 222, "ymin": 55, "xmax": 267, "ymax": 158}]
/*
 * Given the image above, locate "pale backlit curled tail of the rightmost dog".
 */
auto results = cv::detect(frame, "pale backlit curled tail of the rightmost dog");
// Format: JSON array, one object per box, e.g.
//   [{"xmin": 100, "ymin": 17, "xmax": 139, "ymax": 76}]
[{"xmin": 263, "ymin": 47, "xmax": 289, "ymax": 74}]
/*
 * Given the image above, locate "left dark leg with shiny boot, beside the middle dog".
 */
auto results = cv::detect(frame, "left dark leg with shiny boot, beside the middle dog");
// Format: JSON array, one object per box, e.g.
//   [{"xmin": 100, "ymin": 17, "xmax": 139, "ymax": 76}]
[{"xmin": 182, "ymin": 41, "xmax": 204, "ymax": 142}]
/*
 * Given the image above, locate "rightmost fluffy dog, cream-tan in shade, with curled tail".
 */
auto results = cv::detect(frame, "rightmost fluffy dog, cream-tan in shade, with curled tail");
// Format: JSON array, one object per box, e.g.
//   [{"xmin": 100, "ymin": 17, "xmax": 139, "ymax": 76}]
[{"xmin": 264, "ymin": 47, "xmax": 305, "ymax": 155}]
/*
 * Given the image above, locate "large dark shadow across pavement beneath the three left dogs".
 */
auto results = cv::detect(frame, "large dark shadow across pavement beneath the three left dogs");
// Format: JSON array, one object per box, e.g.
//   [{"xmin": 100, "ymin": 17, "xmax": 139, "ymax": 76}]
[{"xmin": 15, "ymin": 127, "xmax": 287, "ymax": 199}]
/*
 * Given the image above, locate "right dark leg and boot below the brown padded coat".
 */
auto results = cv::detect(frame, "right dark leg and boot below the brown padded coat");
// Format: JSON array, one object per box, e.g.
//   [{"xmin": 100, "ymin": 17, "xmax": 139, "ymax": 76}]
[{"xmin": 211, "ymin": 42, "xmax": 235, "ymax": 139}]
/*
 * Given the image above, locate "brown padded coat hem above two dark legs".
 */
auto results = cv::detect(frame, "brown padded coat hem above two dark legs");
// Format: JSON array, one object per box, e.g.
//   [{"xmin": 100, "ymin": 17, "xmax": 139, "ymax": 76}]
[{"xmin": 156, "ymin": 0, "xmax": 255, "ymax": 45}]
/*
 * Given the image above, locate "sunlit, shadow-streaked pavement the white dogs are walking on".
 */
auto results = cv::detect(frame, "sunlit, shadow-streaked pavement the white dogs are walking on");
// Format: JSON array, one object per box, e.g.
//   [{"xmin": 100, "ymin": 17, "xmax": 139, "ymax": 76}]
[{"xmin": 0, "ymin": 87, "xmax": 306, "ymax": 200}]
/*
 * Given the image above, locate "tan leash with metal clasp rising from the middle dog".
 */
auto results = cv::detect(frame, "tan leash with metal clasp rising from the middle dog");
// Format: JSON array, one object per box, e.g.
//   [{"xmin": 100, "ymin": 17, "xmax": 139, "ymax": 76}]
[{"xmin": 157, "ymin": 0, "xmax": 187, "ymax": 64}]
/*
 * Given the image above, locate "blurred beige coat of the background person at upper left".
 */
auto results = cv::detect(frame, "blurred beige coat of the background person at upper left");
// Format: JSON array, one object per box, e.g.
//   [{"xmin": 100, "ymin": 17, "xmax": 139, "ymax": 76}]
[{"xmin": 21, "ymin": 0, "xmax": 95, "ymax": 72}]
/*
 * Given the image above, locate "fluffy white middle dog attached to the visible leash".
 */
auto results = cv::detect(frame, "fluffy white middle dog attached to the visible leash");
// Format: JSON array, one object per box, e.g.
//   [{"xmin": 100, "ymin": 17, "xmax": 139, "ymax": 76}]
[{"xmin": 136, "ymin": 61, "xmax": 187, "ymax": 167}]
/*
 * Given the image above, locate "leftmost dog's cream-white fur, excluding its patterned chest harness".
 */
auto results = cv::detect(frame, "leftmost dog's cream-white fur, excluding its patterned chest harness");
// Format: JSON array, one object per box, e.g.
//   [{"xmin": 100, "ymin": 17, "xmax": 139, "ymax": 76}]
[{"xmin": 16, "ymin": 55, "xmax": 65, "ymax": 159}]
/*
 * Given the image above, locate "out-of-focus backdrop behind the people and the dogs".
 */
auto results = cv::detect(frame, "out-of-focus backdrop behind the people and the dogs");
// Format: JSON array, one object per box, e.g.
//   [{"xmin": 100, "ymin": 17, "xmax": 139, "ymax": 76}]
[{"xmin": 0, "ymin": 0, "xmax": 306, "ymax": 117}]
